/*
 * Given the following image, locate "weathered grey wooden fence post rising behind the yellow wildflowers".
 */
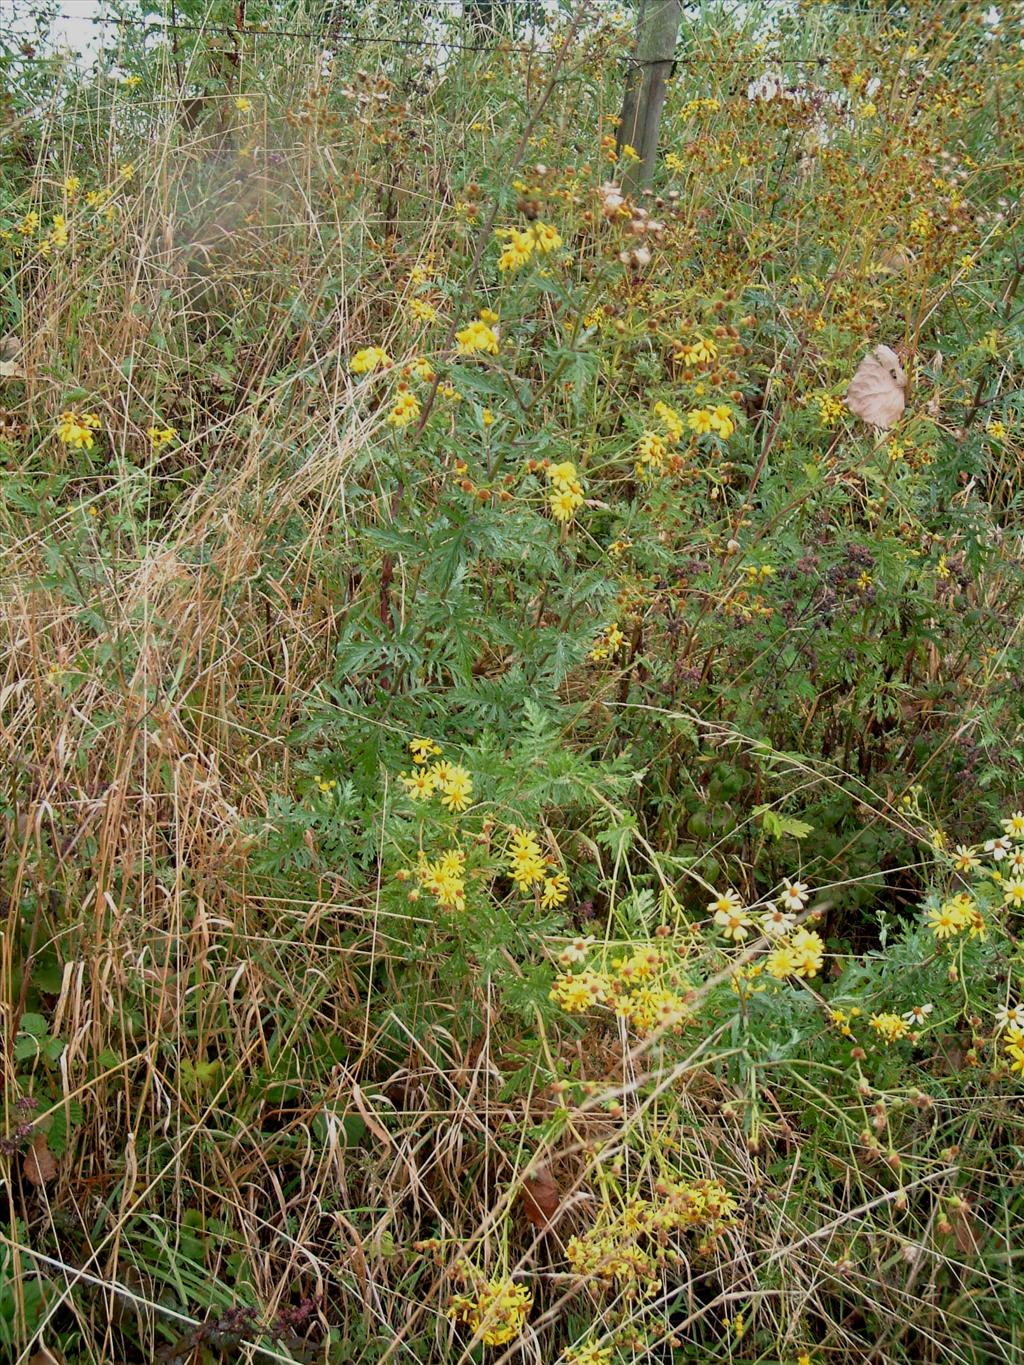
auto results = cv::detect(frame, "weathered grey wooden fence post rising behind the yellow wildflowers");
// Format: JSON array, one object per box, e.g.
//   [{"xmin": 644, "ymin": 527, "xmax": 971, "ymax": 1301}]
[{"xmin": 616, "ymin": 0, "xmax": 683, "ymax": 192}]
